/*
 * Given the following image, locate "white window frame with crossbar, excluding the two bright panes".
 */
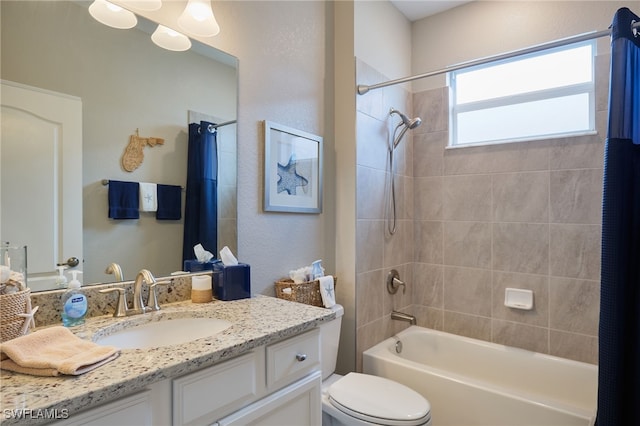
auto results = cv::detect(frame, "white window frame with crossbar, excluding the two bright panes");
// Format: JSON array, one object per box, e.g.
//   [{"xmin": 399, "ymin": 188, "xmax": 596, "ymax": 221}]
[{"xmin": 447, "ymin": 40, "xmax": 597, "ymax": 148}]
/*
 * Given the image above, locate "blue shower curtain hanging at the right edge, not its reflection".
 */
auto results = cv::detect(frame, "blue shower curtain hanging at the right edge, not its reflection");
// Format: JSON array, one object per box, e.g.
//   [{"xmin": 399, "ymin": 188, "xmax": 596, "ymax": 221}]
[{"xmin": 596, "ymin": 8, "xmax": 640, "ymax": 426}]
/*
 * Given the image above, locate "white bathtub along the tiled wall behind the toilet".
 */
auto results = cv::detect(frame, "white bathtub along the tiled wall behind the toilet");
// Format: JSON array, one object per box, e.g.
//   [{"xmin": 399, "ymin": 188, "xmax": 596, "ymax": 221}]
[{"xmin": 363, "ymin": 326, "xmax": 598, "ymax": 426}]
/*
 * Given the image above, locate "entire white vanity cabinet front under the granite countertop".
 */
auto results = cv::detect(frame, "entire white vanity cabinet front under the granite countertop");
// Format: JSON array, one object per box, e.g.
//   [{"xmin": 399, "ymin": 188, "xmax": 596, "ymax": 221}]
[{"xmin": 56, "ymin": 328, "xmax": 322, "ymax": 426}]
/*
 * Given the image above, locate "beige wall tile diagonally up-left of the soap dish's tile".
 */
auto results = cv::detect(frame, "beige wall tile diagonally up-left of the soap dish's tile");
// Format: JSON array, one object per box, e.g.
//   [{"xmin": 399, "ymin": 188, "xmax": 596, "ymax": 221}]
[{"xmin": 444, "ymin": 222, "xmax": 491, "ymax": 269}]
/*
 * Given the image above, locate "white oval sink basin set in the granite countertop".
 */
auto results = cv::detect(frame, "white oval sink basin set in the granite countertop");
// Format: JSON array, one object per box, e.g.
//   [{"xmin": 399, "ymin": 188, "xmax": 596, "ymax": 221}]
[{"xmin": 95, "ymin": 318, "xmax": 232, "ymax": 349}]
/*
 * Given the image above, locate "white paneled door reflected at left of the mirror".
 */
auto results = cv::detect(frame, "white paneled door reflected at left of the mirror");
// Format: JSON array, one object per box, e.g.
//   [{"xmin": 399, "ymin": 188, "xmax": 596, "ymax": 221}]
[{"xmin": 0, "ymin": 80, "xmax": 82, "ymax": 290}]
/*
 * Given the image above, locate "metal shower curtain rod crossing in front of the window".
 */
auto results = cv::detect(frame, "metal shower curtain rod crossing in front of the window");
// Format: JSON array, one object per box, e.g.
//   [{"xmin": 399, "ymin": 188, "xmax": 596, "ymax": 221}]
[{"xmin": 357, "ymin": 22, "xmax": 640, "ymax": 95}]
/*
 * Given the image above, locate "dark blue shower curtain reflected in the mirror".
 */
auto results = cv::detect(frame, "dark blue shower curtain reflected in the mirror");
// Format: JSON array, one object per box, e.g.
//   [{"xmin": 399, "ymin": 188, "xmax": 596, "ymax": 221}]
[{"xmin": 182, "ymin": 121, "xmax": 218, "ymax": 261}]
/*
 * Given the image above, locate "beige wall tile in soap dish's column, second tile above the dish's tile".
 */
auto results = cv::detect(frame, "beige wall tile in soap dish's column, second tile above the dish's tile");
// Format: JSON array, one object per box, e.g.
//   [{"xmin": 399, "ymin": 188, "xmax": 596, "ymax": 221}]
[{"xmin": 493, "ymin": 172, "xmax": 549, "ymax": 223}]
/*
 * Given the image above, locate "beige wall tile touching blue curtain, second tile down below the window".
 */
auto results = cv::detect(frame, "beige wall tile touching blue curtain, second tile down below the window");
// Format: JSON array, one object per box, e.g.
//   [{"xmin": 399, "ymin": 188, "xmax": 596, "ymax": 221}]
[{"xmin": 550, "ymin": 169, "xmax": 602, "ymax": 224}]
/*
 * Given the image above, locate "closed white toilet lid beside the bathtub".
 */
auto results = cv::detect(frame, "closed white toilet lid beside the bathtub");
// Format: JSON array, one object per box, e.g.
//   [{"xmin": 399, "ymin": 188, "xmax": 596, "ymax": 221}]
[{"xmin": 329, "ymin": 373, "xmax": 431, "ymax": 426}]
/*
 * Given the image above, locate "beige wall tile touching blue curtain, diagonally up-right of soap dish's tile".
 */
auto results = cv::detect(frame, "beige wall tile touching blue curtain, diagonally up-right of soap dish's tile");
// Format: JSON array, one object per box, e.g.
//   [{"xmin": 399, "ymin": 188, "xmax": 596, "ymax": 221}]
[{"xmin": 549, "ymin": 224, "xmax": 601, "ymax": 280}]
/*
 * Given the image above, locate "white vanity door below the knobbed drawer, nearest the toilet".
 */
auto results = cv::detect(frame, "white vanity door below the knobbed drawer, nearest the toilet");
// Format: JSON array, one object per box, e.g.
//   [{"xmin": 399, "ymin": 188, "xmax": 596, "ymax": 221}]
[{"xmin": 216, "ymin": 371, "xmax": 322, "ymax": 426}]
